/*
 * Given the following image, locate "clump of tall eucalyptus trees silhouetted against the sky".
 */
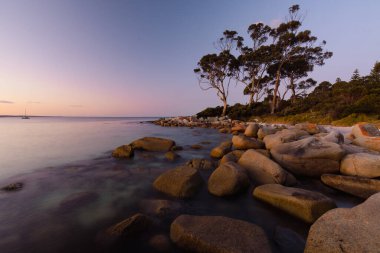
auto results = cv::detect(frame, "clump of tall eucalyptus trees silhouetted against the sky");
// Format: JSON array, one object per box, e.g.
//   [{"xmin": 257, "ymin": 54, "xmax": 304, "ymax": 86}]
[{"xmin": 194, "ymin": 5, "xmax": 332, "ymax": 116}]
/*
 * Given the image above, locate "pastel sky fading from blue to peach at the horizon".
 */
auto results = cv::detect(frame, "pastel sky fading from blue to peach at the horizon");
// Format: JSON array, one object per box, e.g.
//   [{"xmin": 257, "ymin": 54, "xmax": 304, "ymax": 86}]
[{"xmin": 0, "ymin": 0, "xmax": 380, "ymax": 116}]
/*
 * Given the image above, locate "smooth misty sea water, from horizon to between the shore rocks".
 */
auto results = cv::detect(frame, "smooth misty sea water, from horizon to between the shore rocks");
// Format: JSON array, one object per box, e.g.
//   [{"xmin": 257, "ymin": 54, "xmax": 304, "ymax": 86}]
[{"xmin": 0, "ymin": 117, "xmax": 361, "ymax": 253}]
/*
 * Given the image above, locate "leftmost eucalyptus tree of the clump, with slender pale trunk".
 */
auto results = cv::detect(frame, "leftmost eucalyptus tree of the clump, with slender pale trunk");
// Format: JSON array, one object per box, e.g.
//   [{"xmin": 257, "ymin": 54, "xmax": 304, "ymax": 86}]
[{"xmin": 194, "ymin": 30, "xmax": 241, "ymax": 116}]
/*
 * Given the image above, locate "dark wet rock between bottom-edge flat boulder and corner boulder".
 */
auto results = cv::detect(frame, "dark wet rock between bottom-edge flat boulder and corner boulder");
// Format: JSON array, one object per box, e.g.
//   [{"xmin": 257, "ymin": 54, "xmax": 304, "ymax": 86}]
[{"xmin": 273, "ymin": 226, "xmax": 306, "ymax": 253}]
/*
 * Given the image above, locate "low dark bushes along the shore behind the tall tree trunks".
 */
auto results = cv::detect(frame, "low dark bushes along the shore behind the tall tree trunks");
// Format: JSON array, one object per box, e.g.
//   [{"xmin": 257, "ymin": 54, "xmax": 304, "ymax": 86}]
[{"xmin": 197, "ymin": 62, "xmax": 380, "ymax": 120}]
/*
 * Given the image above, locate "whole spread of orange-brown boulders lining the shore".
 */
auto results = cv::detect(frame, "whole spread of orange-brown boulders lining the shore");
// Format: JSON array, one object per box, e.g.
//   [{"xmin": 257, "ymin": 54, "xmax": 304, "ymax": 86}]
[{"xmin": 109, "ymin": 121, "xmax": 380, "ymax": 252}]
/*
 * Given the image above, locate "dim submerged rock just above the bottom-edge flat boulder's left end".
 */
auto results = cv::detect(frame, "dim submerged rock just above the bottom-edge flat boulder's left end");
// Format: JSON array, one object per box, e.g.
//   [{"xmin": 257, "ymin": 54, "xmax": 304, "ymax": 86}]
[{"xmin": 139, "ymin": 199, "xmax": 182, "ymax": 217}]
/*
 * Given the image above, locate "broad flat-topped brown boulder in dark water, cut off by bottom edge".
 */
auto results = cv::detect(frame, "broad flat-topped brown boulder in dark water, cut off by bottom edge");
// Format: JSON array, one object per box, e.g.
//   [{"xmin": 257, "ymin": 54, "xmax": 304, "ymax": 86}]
[{"xmin": 170, "ymin": 215, "xmax": 271, "ymax": 253}]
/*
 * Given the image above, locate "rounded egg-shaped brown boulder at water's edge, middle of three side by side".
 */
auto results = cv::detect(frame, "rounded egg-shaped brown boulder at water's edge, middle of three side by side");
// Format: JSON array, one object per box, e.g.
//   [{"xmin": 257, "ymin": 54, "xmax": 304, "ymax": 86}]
[{"xmin": 208, "ymin": 162, "xmax": 249, "ymax": 197}]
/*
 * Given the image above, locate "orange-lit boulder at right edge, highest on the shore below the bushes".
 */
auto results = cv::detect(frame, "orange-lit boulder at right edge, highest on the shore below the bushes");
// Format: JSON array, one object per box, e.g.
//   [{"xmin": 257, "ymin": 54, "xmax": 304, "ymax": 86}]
[{"xmin": 352, "ymin": 123, "xmax": 380, "ymax": 152}]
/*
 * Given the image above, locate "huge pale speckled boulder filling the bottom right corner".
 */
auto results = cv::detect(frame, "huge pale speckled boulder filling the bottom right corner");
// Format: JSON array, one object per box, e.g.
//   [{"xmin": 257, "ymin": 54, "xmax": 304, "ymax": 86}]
[{"xmin": 305, "ymin": 193, "xmax": 380, "ymax": 253}]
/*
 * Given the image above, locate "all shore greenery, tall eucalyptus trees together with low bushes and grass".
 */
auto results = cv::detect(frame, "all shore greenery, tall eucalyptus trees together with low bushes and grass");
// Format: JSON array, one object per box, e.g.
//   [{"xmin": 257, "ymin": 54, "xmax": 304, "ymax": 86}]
[{"xmin": 194, "ymin": 5, "xmax": 380, "ymax": 125}]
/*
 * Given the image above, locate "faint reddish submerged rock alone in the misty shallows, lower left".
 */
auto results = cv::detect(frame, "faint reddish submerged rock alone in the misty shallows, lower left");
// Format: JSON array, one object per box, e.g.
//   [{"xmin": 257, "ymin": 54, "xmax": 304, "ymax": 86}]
[{"xmin": 59, "ymin": 192, "xmax": 99, "ymax": 211}]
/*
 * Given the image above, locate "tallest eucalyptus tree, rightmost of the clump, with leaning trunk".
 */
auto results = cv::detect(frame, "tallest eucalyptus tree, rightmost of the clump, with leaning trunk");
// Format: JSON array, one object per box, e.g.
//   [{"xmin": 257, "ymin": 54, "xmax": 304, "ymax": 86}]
[{"xmin": 270, "ymin": 5, "xmax": 332, "ymax": 114}]
